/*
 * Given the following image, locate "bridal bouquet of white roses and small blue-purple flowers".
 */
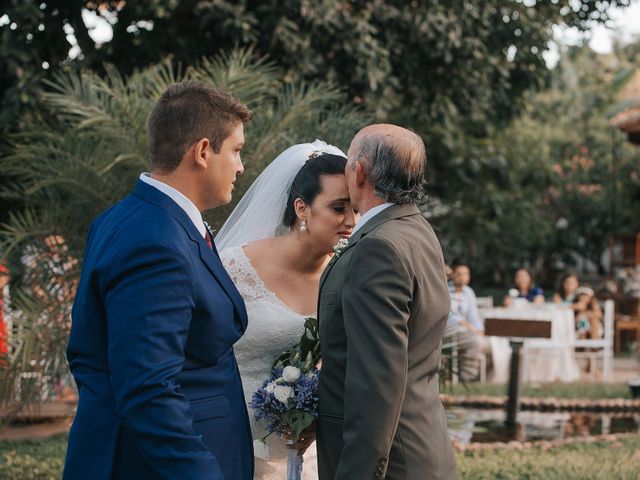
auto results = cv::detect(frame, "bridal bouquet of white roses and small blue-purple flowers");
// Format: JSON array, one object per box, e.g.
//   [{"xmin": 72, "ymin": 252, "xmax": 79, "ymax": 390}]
[{"xmin": 249, "ymin": 317, "xmax": 320, "ymax": 480}]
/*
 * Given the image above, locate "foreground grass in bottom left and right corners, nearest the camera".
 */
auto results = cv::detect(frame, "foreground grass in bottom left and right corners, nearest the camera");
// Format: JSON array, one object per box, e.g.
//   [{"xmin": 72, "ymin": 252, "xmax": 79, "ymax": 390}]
[{"xmin": 0, "ymin": 435, "xmax": 640, "ymax": 480}]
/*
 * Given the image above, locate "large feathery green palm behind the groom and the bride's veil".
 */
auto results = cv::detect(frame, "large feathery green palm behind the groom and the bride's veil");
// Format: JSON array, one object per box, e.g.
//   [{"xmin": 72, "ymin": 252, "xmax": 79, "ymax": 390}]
[{"xmin": 0, "ymin": 49, "xmax": 369, "ymax": 405}]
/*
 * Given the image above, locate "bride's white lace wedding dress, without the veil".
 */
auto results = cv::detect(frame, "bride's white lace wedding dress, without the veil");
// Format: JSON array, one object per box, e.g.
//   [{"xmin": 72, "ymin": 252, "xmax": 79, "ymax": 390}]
[{"xmin": 220, "ymin": 247, "xmax": 318, "ymax": 480}]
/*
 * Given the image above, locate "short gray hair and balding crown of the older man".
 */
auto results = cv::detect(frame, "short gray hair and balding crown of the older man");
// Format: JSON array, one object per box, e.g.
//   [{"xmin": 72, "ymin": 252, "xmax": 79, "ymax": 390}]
[{"xmin": 349, "ymin": 130, "xmax": 427, "ymax": 204}]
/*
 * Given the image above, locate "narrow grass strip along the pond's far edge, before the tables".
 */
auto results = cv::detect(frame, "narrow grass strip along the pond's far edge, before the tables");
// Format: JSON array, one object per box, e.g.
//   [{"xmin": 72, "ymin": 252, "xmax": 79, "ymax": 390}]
[{"xmin": 440, "ymin": 383, "xmax": 631, "ymax": 399}]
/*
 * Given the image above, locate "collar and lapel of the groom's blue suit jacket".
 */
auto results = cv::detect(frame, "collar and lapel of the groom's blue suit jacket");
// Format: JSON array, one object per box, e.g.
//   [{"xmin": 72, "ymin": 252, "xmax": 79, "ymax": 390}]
[{"xmin": 133, "ymin": 180, "xmax": 248, "ymax": 332}]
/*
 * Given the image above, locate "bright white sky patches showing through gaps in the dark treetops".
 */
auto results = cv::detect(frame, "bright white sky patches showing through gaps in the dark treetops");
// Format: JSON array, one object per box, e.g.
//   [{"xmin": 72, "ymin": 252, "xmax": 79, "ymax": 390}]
[{"xmin": 79, "ymin": 0, "xmax": 640, "ymax": 67}]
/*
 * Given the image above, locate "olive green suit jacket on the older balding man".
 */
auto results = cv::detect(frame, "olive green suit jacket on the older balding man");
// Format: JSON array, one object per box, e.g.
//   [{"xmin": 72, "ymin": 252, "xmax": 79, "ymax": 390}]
[{"xmin": 317, "ymin": 205, "xmax": 456, "ymax": 480}]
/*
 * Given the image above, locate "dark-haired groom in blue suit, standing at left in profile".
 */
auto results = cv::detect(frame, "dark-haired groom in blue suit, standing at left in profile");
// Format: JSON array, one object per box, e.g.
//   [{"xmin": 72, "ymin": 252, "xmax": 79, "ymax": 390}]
[{"xmin": 64, "ymin": 81, "xmax": 253, "ymax": 480}]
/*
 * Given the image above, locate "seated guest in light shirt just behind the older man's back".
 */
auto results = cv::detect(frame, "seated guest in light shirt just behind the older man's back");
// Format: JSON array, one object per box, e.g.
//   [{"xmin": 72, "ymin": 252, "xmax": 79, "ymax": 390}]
[{"xmin": 448, "ymin": 262, "xmax": 490, "ymax": 382}]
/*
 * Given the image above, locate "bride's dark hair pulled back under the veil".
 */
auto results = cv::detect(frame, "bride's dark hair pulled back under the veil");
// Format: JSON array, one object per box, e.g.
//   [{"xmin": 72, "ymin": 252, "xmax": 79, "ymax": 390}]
[{"xmin": 282, "ymin": 153, "xmax": 347, "ymax": 228}]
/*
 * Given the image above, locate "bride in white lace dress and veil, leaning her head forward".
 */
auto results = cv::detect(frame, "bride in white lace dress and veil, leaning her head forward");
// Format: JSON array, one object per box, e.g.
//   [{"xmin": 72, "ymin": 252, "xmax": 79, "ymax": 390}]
[{"xmin": 216, "ymin": 140, "xmax": 357, "ymax": 480}]
